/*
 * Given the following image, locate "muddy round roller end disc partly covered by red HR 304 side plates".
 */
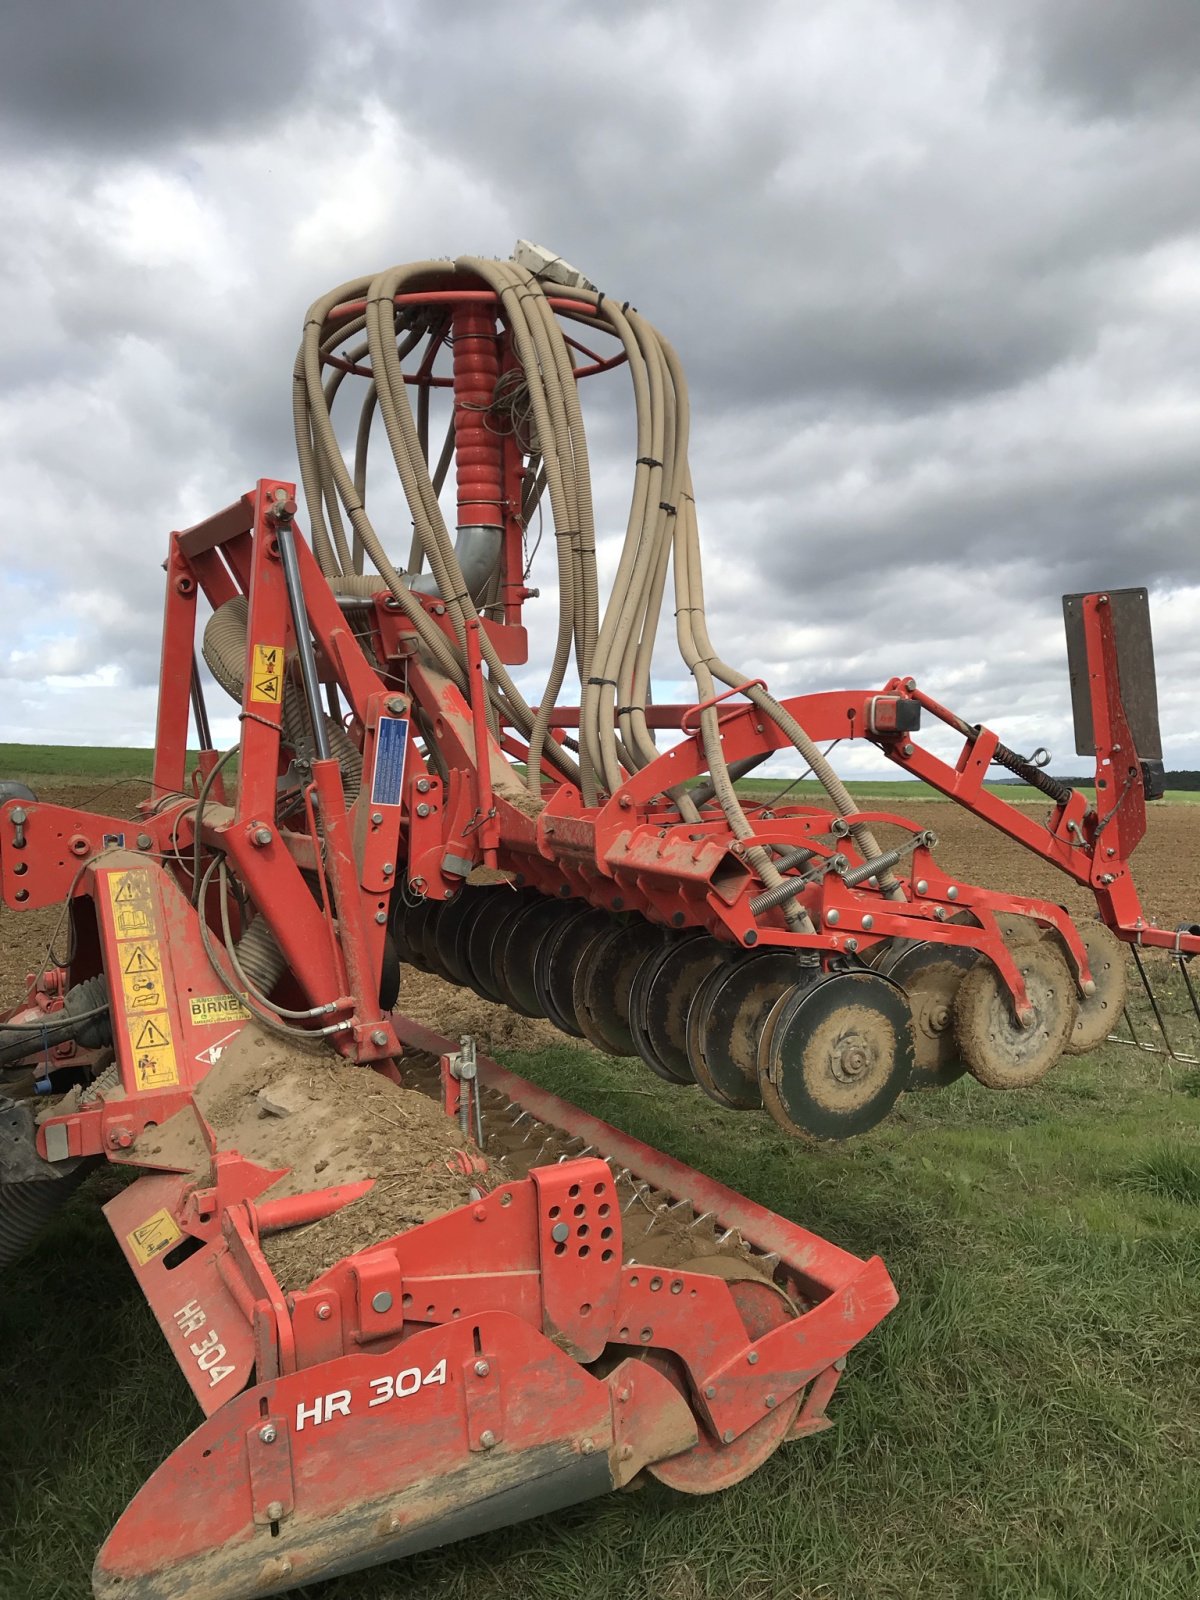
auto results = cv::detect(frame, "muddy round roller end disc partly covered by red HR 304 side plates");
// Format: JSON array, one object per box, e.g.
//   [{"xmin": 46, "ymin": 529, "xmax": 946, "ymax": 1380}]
[{"xmin": 643, "ymin": 1256, "xmax": 802, "ymax": 1494}]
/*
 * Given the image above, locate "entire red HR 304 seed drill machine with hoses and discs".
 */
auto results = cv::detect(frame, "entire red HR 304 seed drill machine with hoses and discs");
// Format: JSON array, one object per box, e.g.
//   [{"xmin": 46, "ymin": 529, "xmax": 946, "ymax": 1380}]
[{"xmin": 0, "ymin": 246, "xmax": 1200, "ymax": 1600}]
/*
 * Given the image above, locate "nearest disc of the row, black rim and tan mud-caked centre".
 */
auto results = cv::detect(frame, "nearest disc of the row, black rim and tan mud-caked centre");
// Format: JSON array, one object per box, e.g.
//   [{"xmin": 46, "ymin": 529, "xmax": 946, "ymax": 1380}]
[{"xmin": 758, "ymin": 970, "xmax": 912, "ymax": 1139}]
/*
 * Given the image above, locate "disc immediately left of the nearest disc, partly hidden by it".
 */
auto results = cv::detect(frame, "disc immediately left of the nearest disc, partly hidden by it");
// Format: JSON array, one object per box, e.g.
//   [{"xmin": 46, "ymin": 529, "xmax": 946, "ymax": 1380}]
[{"xmin": 688, "ymin": 950, "xmax": 811, "ymax": 1110}]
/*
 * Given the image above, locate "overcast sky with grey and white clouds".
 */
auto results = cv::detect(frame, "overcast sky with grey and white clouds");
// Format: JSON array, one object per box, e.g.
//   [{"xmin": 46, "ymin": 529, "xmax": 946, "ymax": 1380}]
[{"xmin": 0, "ymin": 0, "xmax": 1200, "ymax": 773}]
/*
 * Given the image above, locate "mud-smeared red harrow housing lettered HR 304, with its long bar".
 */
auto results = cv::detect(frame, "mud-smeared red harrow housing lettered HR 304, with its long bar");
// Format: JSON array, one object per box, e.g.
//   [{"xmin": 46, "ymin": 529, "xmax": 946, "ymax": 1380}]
[{"xmin": 94, "ymin": 1024, "xmax": 896, "ymax": 1600}]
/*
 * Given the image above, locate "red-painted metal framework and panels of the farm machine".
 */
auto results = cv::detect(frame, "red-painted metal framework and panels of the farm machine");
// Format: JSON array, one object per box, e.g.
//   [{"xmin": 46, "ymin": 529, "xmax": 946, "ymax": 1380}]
[{"xmin": 0, "ymin": 288, "xmax": 1200, "ymax": 1600}]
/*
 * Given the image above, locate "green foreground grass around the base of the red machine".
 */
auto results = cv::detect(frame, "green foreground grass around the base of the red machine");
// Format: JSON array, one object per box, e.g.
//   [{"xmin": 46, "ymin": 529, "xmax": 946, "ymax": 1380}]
[{"xmin": 0, "ymin": 1046, "xmax": 1200, "ymax": 1600}]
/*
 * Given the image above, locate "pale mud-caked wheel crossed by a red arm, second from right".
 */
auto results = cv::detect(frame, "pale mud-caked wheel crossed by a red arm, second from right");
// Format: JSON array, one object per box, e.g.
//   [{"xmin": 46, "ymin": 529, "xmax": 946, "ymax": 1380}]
[{"xmin": 954, "ymin": 939, "xmax": 1078, "ymax": 1090}]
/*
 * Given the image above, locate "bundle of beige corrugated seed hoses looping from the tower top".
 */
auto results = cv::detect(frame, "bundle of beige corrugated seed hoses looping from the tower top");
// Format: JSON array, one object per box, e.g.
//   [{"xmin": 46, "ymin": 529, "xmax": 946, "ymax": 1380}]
[{"xmin": 205, "ymin": 256, "xmax": 901, "ymax": 930}]
